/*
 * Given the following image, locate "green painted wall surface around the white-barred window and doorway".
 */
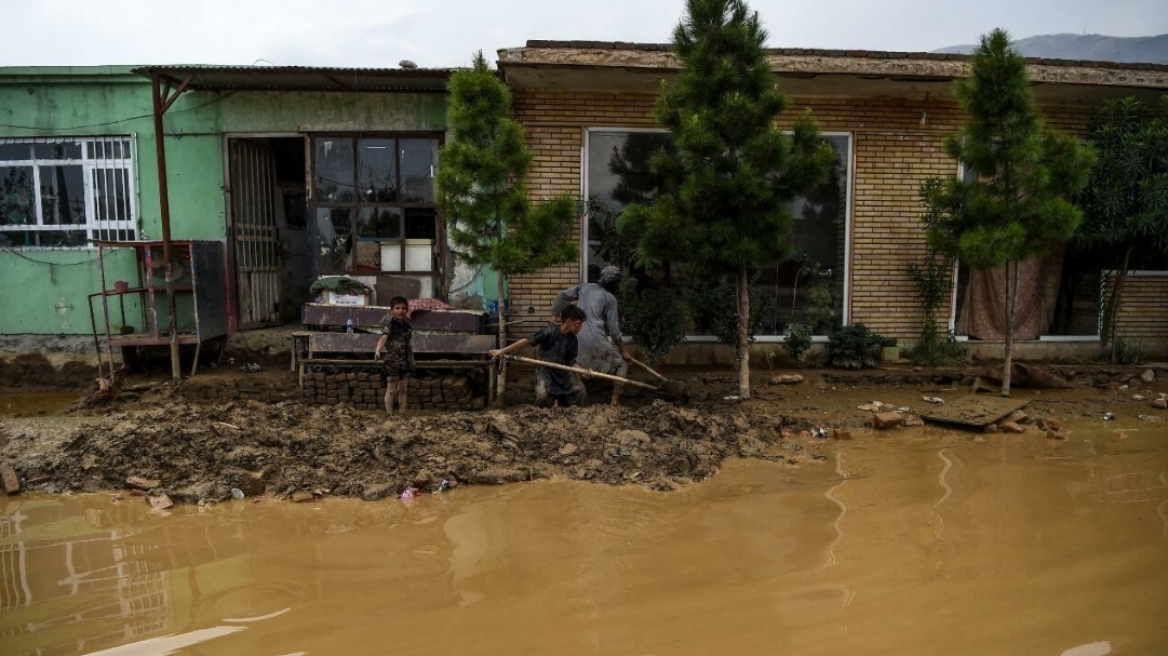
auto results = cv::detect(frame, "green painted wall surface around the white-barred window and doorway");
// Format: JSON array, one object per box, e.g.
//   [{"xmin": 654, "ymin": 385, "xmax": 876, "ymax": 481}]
[{"xmin": 0, "ymin": 67, "xmax": 446, "ymax": 334}]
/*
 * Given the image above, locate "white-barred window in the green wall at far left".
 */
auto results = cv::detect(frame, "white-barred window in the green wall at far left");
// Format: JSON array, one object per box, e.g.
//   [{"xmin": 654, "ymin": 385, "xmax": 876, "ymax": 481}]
[{"xmin": 0, "ymin": 137, "xmax": 138, "ymax": 249}]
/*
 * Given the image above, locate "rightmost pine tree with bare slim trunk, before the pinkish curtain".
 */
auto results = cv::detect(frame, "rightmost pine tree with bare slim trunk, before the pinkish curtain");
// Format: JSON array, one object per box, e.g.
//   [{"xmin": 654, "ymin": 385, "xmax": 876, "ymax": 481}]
[{"xmin": 923, "ymin": 29, "xmax": 1094, "ymax": 397}]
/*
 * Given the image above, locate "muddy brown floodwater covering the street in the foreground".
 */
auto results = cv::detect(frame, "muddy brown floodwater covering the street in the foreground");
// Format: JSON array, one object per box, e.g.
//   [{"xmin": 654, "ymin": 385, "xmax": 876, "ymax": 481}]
[{"xmin": 0, "ymin": 426, "xmax": 1168, "ymax": 656}]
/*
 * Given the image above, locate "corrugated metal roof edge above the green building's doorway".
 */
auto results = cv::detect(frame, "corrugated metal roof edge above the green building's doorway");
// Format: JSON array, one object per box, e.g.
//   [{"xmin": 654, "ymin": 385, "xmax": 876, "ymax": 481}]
[{"xmin": 133, "ymin": 64, "xmax": 456, "ymax": 93}]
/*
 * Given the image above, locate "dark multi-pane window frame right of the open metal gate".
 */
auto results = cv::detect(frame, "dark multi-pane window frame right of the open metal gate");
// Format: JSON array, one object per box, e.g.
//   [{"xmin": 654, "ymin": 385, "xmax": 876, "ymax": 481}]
[{"xmin": 306, "ymin": 130, "xmax": 447, "ymax": 296}]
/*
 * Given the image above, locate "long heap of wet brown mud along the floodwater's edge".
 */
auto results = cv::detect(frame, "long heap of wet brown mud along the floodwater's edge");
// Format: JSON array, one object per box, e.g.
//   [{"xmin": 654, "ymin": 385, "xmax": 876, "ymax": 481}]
[{"xmin": 0, "ymin": 402, "xmax": 825, "ymax": 503}]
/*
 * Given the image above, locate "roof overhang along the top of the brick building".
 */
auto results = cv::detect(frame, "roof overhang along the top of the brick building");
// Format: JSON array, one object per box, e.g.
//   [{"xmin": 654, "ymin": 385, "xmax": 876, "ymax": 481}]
[{"xmin": 499, "ymin": 41, "xmax": 1168, "ymax": 106}]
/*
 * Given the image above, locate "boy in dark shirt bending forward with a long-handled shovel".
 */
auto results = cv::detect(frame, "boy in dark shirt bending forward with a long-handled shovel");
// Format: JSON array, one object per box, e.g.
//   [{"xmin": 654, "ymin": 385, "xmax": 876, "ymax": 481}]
[{"xmin": 491, "ymin": 306, "xmax": 588, "ymax": 407}]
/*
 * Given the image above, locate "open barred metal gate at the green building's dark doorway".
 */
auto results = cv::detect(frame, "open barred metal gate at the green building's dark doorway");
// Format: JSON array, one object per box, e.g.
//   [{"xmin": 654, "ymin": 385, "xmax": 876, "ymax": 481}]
[{"xmin": 229, "ymin": 139, "xmax": 284, "ymax": 330}]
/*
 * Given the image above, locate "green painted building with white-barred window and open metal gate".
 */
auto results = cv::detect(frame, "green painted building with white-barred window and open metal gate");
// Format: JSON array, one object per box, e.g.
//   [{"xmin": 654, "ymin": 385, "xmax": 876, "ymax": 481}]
[{"xmin": 0, "ymin": 67, "xmax": 494, "ymax": 335}]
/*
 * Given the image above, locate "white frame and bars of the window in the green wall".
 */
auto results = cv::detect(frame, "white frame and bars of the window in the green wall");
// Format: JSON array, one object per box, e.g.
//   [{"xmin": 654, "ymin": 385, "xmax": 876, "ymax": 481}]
[{"xmin": 0, "ymin": 134, "xmax": 141, "ymax": 251}]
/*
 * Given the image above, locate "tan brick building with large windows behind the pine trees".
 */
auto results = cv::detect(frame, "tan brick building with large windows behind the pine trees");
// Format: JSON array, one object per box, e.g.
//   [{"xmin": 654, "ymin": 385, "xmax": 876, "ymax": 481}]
[{"xmin": 499, "ymin": 41, "xmax": 1168, "ymax": 362}]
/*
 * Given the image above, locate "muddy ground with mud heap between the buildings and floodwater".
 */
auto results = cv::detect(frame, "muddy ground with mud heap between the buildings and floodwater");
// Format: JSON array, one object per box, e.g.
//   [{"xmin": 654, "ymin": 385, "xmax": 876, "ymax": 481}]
[{"xmin": 0, "ymin": 362, "xmax": 1168, "ymax": 503}]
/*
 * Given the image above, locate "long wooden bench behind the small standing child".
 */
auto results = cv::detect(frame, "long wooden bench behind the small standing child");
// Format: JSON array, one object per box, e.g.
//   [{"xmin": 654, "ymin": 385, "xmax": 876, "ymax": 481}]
[{"xmin": 292, "ymin": 303, "xmax": 496, "ymax": 403}]
